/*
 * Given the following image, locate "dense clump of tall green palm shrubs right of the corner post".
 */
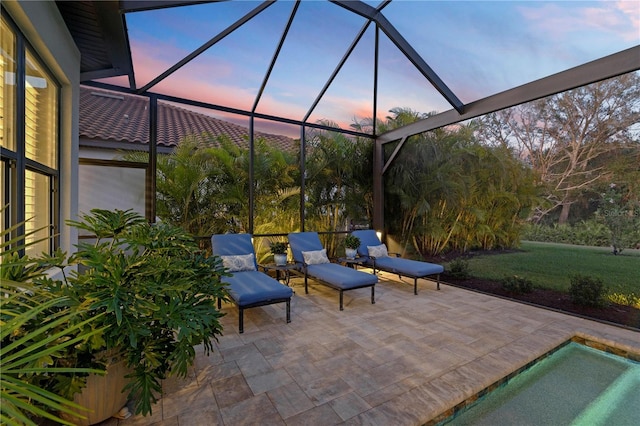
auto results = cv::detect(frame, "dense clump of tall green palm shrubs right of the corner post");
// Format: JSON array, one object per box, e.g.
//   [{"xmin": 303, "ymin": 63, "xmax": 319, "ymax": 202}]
[{"xmin": 384, "ymin": 113, "xmax": 537, "ymax": 255}]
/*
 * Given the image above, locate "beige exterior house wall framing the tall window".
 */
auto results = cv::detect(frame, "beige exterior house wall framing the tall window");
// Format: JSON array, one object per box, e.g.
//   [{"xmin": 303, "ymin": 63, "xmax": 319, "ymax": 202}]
[{"xmin": 2, "ymin": 1, "xmax": 80, "ymax": 252}]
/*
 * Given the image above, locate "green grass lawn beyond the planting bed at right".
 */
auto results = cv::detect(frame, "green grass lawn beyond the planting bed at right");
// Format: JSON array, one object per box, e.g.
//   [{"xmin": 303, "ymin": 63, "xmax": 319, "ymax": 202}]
[{"xmin": 450, "ymin": 241, "xmax": 640, "ymax": 295}]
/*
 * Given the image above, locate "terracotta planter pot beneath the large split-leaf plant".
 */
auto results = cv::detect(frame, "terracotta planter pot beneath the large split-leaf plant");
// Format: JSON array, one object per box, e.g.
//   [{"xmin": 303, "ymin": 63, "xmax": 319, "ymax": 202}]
[{"xmin": 62, "ymin": 352, "xmax": 131, "ymax": 426}]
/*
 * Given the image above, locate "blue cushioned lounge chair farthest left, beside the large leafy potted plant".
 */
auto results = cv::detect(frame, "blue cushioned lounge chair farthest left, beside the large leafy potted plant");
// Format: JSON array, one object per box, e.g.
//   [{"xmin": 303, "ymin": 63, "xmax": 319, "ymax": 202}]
[{"xmin": 211, "ymin": 234, "xmax": 293, "ymax": 333}]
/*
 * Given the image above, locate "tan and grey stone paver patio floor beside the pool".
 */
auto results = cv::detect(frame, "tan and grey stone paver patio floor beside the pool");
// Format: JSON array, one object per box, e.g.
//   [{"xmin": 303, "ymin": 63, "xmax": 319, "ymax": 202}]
[{"xmin": 110, "ymin": 273, "xmax": 640, "ymax": 426}]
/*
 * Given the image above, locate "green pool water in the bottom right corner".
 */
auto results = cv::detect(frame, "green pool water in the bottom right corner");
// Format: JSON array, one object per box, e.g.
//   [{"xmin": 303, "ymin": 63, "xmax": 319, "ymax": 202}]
[{"xmin": 445, "ymin": 342, "xmax": 640, "ymax": 426}]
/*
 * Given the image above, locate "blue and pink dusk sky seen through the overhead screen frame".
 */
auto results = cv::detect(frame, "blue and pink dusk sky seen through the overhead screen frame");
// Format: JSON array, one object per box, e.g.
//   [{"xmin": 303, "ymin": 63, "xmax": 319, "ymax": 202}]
[{"xmin": 102, "ymin": 0, "xmax": 640, "ymax": 136}]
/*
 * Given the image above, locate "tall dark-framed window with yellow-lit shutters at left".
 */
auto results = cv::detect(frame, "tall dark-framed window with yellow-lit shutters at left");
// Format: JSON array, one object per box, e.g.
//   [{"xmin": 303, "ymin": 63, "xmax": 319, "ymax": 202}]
[{"xmin": 0, "ymin": 15, "xmax": 60, "ymax": 255}]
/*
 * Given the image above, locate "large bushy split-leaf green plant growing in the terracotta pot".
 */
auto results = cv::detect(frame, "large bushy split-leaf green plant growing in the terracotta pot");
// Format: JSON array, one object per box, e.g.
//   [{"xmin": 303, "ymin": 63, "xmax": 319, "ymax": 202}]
[{"xmin": 6, "ymin": 209, "xmax": 226, "ymax": 424}]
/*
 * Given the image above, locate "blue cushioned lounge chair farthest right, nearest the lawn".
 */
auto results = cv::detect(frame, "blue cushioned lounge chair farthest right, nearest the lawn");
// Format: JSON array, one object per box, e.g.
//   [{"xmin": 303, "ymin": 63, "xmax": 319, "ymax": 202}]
[{"xmin": 351, "ymin": 229, "xmax": 444, "ymax": 294}]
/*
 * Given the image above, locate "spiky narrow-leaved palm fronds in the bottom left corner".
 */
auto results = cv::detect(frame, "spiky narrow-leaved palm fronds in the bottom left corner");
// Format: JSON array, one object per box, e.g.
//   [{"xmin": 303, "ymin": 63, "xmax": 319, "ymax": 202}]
[{"xmin": 0, "ymin": 216, "xmax": 104, "ymax": 426}]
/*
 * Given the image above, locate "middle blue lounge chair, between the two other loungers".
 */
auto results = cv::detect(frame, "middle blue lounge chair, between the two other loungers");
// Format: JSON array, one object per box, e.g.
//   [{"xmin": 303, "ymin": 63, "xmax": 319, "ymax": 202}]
[{"xmin": 289, "ymin": 232, "xmax": 378, "ymax": 311}]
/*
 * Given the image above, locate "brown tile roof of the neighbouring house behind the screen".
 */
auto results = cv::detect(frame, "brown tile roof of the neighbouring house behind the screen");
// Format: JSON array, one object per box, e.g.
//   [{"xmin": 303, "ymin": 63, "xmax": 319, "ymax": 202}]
[{"xmin": 80, "ymin": 86, "xmax": 296, "ymax": 151}]
